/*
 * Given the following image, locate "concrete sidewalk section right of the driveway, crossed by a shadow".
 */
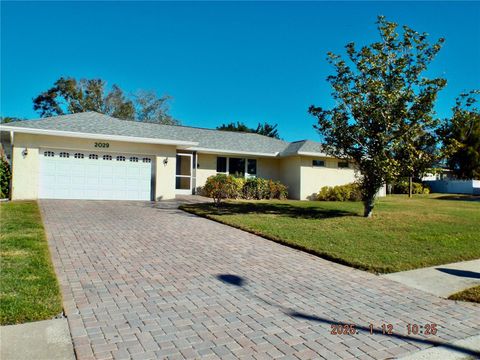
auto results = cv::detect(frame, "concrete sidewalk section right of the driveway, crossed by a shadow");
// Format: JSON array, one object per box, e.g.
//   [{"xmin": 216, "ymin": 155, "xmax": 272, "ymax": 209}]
[{"xmin": 382, "ymin": 259, "xmax": 480, "ymax": 298}]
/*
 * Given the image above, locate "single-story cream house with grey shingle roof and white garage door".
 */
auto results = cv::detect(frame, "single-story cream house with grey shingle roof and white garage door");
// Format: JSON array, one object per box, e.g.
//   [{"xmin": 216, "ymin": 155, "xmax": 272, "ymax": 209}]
[{"xmin": 0, "ymin": 112, "xmax": 372, "ymax": 200}]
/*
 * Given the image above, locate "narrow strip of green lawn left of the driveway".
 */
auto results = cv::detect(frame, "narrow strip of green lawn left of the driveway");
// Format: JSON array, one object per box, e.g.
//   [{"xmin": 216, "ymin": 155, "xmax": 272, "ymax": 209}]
[{"xmin": 0, "ymin": 201, "xmax": 62, "ymax": 325}]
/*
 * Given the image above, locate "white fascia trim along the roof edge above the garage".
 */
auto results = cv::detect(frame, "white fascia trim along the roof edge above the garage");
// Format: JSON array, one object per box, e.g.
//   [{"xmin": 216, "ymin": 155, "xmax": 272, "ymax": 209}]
[{"xmin": 0, "ymin": 125, "xmax": 198, "ymax": 145}]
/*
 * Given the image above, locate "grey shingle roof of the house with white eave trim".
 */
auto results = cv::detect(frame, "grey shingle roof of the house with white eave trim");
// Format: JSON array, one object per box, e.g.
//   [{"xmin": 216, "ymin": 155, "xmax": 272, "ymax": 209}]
[{"xmin": 0, "ymin": 112, "xmax": 324, "ymax": 156}]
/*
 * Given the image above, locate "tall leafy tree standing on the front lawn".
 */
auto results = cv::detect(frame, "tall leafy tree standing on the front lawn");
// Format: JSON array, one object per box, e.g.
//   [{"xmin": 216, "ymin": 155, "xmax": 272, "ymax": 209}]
[{"xmin": 309, "ymin": 16, "xmax": 446, "ymax": 217}]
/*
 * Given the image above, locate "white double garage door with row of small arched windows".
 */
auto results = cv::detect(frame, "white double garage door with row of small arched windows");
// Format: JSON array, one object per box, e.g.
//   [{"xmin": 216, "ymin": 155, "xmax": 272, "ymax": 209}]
[{"xmin": 39, "ymin": 149, "xmax": 152, "ymax": 200}]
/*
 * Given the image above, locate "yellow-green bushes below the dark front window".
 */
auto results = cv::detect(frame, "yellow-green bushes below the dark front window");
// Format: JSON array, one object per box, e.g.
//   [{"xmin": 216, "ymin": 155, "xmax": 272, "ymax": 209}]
[{"xmin": 202, "ymin": 174, "xmax": 288, "ymax": 205}]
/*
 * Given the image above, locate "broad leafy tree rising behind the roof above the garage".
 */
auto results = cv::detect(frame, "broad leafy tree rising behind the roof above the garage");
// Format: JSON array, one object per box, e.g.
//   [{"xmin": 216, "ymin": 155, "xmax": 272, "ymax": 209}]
[{"xmin": 33, "ymin": 77, "xmax": 179, "ymax": 125}]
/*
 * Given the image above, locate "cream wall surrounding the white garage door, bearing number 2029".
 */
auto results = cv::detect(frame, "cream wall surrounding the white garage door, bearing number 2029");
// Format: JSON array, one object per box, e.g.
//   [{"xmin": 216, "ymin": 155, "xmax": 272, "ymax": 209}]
[{"xmin": 12, "ymin": 133, "xmax": 176, "ymax": 200}]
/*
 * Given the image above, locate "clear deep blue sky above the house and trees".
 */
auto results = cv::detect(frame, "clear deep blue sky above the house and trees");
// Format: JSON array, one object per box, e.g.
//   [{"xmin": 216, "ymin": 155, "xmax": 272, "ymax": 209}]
[{"xmin": 0, "ymin": 2, "xmax": 480, "ymax": 140}]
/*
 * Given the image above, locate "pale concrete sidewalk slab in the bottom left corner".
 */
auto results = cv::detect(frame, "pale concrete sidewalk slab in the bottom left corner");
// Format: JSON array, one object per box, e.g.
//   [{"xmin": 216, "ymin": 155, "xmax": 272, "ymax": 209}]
[{"xmin": 0, "ymin": 319, "xmax": 75, "ymax": 360}]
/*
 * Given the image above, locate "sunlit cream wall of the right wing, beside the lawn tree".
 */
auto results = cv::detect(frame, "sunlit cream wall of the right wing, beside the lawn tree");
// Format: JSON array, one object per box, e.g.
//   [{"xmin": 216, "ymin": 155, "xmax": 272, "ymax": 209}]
[{"xmin": 300, "ymin": 156, "xmax": 356, "ymax": 200}]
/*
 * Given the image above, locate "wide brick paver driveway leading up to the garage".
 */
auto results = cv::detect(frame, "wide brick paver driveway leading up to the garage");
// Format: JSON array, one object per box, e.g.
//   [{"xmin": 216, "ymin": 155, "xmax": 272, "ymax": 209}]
[{"xmin": 41, "ymin": 200, "xmax": 480, "ymax": 359}]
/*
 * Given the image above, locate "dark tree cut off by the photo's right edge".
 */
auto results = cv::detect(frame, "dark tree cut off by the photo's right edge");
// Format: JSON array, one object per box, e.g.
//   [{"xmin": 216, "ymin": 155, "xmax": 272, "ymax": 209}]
[{"xmin": 438, "ymin": 90, "xmax": 480, "ymax": 179}]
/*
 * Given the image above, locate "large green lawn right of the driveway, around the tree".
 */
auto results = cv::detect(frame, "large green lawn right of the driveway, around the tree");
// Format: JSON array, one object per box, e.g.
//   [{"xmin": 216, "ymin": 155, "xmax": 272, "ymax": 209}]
[{"xmin": 181, "ymin": 195, "xmax": 480, "ymax": 273}]
